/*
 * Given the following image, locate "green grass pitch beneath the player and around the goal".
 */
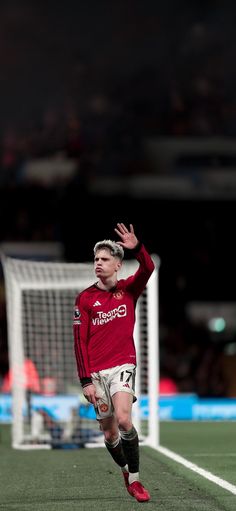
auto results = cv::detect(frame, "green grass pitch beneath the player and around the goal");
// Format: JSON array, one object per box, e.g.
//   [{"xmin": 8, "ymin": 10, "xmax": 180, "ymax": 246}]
[{"xmin": 0, "ymin": 422, "xmax": 236, "ymax": 511}]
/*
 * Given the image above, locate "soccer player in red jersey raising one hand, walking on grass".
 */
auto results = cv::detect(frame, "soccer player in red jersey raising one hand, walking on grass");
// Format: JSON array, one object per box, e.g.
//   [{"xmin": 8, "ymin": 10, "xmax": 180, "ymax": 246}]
[{"xmin": 73, "ymin": 223, "xmax": 154, "ymax": 502}]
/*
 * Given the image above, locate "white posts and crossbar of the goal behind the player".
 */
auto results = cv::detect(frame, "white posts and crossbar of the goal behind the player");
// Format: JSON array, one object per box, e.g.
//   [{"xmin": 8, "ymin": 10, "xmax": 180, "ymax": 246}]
[{"xmin": 1, "ymin": 254, "xmax": 160, "ymax": 449}]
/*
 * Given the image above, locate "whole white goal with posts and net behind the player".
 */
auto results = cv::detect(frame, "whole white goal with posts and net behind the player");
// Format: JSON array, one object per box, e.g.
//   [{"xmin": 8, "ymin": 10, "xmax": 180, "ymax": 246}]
[{"xmin": 1, "ymin": 254, "xmax": 159, "ymax": 449}]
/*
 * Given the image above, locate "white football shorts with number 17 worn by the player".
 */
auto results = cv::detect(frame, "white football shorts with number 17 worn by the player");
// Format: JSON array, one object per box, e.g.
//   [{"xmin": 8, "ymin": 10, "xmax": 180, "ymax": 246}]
[{"xmin": 91, "ymin": 364, "xmax": 137, "ymax": 420}]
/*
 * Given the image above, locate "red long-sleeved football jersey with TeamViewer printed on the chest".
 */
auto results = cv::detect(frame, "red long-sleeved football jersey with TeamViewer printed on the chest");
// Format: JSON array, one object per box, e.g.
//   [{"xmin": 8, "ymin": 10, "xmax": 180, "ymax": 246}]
[{"xmin": 73, "ymin": 244, "xmax": 154, "ymax": 379}]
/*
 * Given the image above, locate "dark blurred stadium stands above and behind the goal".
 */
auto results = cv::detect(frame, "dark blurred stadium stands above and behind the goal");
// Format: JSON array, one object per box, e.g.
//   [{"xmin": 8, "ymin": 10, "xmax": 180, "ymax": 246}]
[{"xmin": 0, "ymin": 0, "xmax": 236, "ymax": 396}]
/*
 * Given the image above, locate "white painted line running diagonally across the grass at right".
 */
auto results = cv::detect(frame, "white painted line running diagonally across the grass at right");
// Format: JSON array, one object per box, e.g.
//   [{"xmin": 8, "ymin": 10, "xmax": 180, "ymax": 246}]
[{"xmin": 157, "ymin": 446, "xmax": 236, "ymax": 495}]
